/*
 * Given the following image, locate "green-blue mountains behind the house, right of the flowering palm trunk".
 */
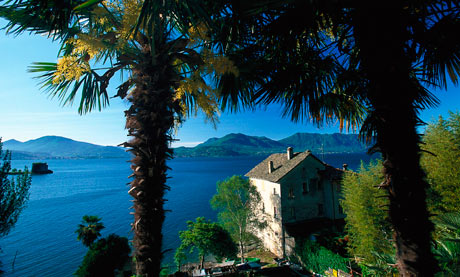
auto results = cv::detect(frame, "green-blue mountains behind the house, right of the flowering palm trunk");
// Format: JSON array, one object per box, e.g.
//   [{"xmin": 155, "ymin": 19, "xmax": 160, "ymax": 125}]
[{"xmin": 174, "ymin": 133, "xmax": 367, "ymax": 157}]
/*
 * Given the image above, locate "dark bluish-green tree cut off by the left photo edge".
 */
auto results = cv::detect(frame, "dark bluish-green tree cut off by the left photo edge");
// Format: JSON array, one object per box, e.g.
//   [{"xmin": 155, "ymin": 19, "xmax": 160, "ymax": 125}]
[{"xmin": 0, "ymin": 139, "xmax": 32, "ymax": 237}]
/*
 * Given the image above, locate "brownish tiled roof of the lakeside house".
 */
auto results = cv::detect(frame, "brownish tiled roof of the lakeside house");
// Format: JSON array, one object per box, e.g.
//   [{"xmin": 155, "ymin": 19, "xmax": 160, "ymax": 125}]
[{"xmin": 245, "ymin": 150, "xmax": 327, "ymax": 183}]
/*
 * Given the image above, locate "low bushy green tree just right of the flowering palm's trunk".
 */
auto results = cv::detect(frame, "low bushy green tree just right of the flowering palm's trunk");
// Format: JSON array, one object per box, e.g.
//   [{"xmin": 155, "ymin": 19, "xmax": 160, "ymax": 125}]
[{"xmin": 175, "ymin": 217, "xmax": 237, "ymax": 268}]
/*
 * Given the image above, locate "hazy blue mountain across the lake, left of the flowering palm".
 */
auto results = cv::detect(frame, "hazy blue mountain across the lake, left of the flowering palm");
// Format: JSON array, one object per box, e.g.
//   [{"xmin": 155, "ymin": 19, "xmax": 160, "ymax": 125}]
[{"xmin": 3, "ymin": 136, "xmax": 129, "ymax": 159}]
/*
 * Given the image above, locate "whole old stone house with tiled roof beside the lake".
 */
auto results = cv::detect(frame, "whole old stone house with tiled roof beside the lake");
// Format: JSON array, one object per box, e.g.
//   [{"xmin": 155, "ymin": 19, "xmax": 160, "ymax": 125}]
[{"xmin": 245, "ymin": 147, "xmax": 346, "ymax": 257}]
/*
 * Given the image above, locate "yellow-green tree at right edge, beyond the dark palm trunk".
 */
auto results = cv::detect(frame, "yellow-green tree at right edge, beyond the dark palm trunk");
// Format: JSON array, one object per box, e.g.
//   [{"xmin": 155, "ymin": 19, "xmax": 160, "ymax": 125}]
[{"xmin": 421, "ymin": 112, "xmax": 460, "ymax": 213}]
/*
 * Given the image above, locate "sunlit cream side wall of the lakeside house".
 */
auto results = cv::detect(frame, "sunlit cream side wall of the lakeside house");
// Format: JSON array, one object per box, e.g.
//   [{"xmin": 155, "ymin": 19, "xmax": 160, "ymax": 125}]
[{"xmin": 250, "ymin": 178, "xmax": 283, "ymax": 257}]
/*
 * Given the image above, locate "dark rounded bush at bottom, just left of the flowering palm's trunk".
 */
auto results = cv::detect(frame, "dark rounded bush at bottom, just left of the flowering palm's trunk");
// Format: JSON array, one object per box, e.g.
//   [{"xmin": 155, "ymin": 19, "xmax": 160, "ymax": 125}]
[{"xmin": 74, "ymin": 234, "xmax": 131, "ymax": 277}]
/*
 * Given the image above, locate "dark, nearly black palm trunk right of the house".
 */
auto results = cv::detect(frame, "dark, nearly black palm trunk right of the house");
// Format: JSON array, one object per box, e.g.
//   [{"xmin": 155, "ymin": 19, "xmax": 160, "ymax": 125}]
[{"xmin": 354, "ymin": 1, "xmax": 436, "ymax": 276}]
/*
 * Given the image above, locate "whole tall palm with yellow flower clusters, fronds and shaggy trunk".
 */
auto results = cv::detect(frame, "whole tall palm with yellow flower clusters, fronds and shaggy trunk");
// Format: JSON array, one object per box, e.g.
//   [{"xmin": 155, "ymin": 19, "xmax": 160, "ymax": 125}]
[{"xmin": 1, "ymin": 0, "xmax": 237, "ymax": 276}]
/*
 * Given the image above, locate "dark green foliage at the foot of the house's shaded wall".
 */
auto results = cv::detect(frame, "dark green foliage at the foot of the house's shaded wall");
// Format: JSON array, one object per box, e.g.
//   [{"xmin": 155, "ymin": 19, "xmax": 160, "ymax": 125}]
[{"xmin": 294, "ymin": 240, "xmax": 349, "ymax": 274}]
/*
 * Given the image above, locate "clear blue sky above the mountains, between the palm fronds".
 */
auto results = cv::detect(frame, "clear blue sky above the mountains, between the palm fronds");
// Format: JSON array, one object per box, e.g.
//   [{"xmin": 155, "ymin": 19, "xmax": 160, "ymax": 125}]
[{"xmin": 0, "ymin": 28, "xmax": 460, "ymax": 146}]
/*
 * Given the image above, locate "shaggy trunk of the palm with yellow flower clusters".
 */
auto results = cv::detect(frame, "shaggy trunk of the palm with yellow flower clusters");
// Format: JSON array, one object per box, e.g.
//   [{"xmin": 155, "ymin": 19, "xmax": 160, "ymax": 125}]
[{"xmin": 126, "ymin": 47, "xmax": 174, "ymax": 276}]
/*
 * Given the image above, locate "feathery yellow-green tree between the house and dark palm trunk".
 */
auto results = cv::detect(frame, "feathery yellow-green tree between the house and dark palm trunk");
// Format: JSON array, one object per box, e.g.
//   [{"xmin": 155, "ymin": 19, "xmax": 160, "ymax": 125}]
[{"xmin": 340, "ymin": 161, "xmax": 394, "ymax": 264}]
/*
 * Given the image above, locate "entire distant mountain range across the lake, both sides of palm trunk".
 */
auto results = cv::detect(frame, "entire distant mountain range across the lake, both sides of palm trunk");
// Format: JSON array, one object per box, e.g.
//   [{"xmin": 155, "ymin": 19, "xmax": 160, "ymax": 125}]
[{"xmin": 3, "ymin": 133, "xmax": 367, "ymax": 160}]
